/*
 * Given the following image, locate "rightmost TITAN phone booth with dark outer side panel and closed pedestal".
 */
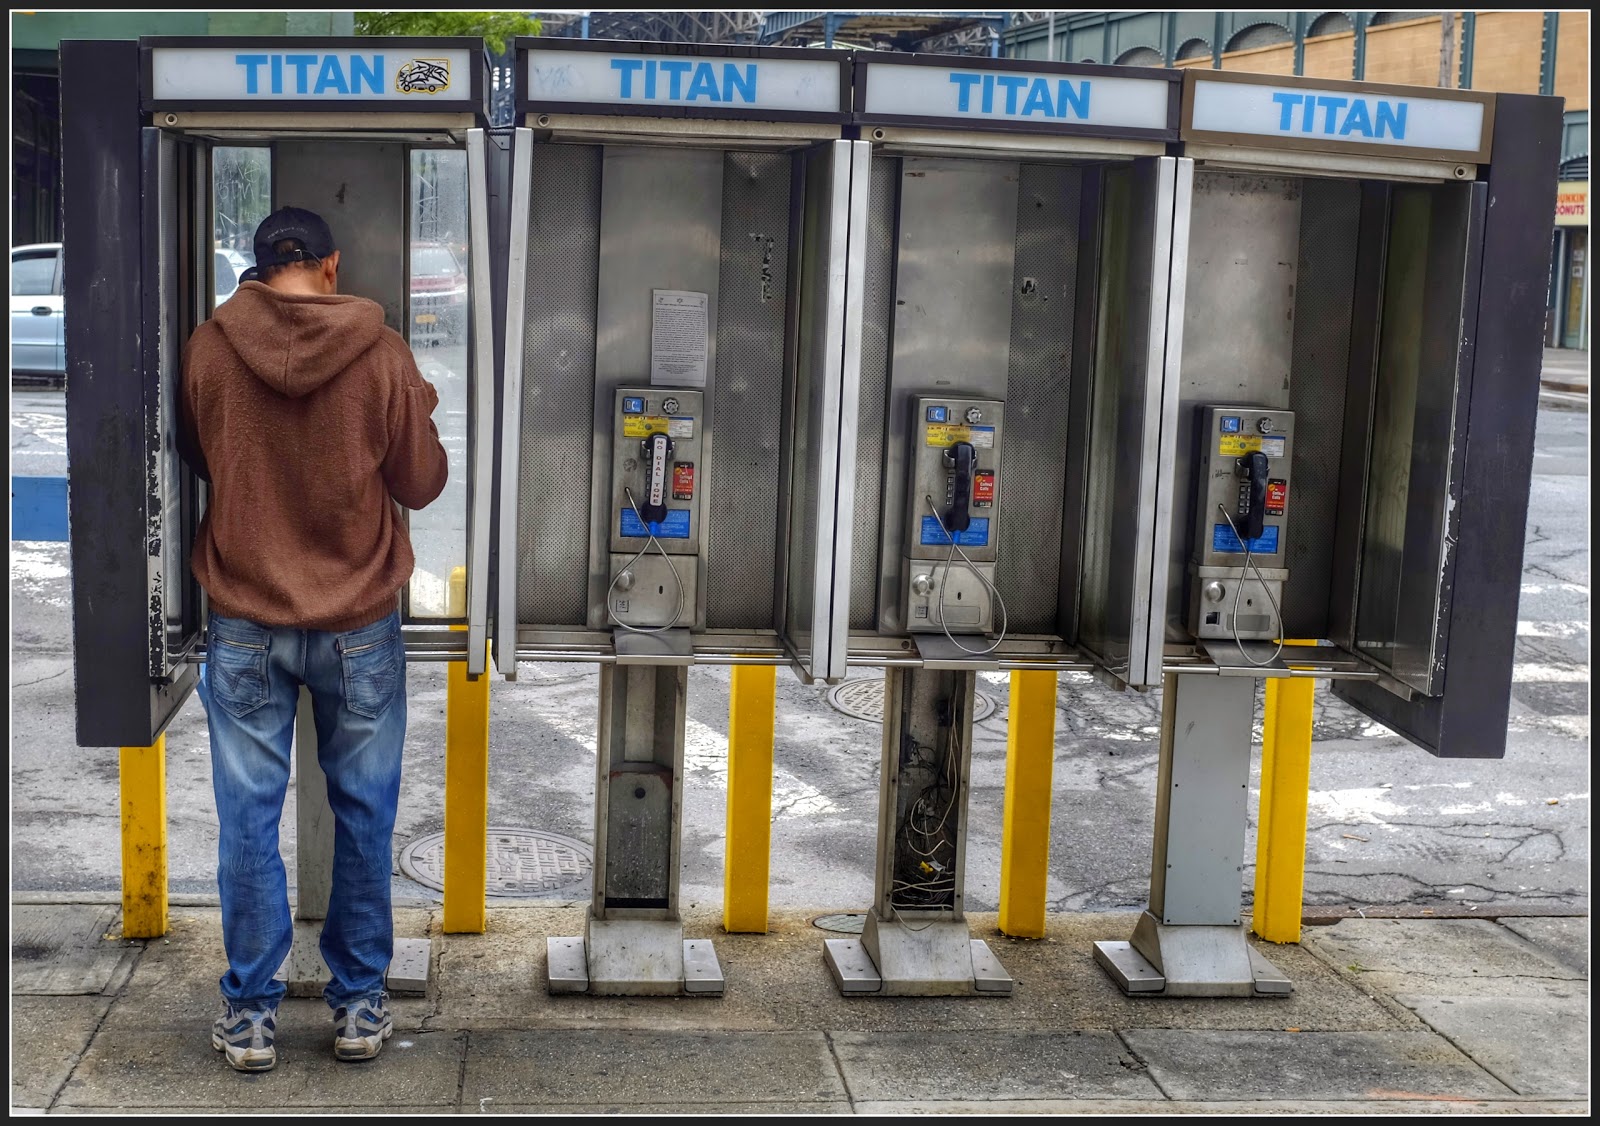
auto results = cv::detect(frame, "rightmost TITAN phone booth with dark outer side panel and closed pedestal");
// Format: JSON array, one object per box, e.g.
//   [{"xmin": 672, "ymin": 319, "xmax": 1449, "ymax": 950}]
[{"xmin": 1096, "ymin": 70, "xmax": 1562, "ymax": 996}]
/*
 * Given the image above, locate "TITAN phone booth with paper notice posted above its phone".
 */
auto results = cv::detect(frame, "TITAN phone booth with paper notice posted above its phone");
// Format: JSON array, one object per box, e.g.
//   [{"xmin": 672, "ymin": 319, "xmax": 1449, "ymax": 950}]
[{"xmin": 505, "ymin": 38, "xmax": 864, "ymax": 995}]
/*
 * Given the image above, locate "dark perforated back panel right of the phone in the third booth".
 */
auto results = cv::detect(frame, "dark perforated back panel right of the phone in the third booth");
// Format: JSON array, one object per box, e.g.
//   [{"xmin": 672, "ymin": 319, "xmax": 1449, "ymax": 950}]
[{"xmin": 995, "ymin": 165, "xmax": 1083, "ymax": 633}]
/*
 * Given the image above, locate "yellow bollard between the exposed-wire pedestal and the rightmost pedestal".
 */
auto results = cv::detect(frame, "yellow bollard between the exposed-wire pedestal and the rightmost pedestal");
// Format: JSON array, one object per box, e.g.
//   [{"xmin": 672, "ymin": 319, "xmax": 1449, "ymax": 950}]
[{"xmin": 1000, "ymin": 670, "xmax": 1056, "ymax": 939}]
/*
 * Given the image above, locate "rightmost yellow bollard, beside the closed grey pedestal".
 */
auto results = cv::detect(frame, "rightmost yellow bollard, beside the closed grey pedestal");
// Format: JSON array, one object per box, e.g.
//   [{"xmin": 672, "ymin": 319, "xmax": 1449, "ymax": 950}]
[{"xmin": 1250, "ymin": 641, "xmax": 1317, "ymax": 942}]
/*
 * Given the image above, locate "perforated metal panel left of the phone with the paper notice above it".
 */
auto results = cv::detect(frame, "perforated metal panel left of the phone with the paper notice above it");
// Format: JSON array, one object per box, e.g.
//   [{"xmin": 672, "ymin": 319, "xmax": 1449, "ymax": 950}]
[{"xmin": 517, "ymin": 144, "xmax": 600, "ymax": 627}]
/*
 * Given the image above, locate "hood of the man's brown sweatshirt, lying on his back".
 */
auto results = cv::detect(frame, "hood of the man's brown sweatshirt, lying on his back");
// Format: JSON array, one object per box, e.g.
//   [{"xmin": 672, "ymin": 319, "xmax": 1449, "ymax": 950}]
[{"xmin": 213, "ymin": 282, "xmax": 384, "ymax": 398}]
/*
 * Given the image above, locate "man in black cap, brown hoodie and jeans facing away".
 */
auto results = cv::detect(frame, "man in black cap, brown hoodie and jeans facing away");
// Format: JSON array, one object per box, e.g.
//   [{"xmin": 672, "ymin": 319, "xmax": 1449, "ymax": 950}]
[{"xmin": 182, "ymin": 208, "xmax": 448, "ymax": 1072}]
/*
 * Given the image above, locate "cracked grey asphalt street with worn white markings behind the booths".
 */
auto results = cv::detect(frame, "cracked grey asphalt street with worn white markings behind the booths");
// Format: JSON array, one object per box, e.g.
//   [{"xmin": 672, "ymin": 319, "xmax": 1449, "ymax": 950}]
[{"xmin": 11, "ymin": 392, "xmax": 1590, "ymax": 913}]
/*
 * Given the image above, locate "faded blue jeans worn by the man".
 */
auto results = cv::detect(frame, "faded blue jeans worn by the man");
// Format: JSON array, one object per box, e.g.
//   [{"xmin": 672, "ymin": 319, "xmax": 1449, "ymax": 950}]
[{"xmin": 200, "ymin": 611, "xmax": 405, "ymax": 1009}]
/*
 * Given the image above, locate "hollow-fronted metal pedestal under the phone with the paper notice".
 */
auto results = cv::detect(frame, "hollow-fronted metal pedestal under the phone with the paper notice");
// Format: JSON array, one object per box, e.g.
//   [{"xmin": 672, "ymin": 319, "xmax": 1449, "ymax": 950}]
[{"xmin": 546, "ymin": 642, "xmax": 723, "ymax": 996}]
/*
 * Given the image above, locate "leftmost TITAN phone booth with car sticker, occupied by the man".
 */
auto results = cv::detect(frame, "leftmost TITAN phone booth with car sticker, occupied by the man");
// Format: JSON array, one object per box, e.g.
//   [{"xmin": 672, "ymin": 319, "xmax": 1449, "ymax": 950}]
[{"xmin": 61, "ymin": 37, "xmax": 493, "ymax": 992}]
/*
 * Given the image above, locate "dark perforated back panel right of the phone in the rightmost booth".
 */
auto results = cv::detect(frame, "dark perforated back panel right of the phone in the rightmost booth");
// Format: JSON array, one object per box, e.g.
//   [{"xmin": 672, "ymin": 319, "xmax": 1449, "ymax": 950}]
[{"xmin": 1283, "ymin": 179, "xmax": 1362, "ymax": 637}]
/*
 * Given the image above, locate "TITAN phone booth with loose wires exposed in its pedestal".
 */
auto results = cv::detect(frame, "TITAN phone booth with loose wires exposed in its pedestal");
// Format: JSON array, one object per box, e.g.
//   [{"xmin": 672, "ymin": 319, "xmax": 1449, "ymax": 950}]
[{"xmin": 824, "ymin": 54, "xmax": 1189, "ymax": 996}]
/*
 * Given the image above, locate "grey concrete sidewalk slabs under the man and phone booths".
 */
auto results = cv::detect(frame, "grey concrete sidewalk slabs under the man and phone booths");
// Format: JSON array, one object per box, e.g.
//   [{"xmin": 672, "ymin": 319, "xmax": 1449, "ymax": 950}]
[{"xmin": 11, "ymin": 896, "xmax": 1589, "ymax": 1115}]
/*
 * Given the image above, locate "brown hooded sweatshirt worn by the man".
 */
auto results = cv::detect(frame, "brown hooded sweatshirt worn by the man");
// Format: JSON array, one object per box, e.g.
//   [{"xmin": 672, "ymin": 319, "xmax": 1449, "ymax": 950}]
[{"xmin": 182, "ymin": 282, "xmax": 448, "ymax": 632}]
